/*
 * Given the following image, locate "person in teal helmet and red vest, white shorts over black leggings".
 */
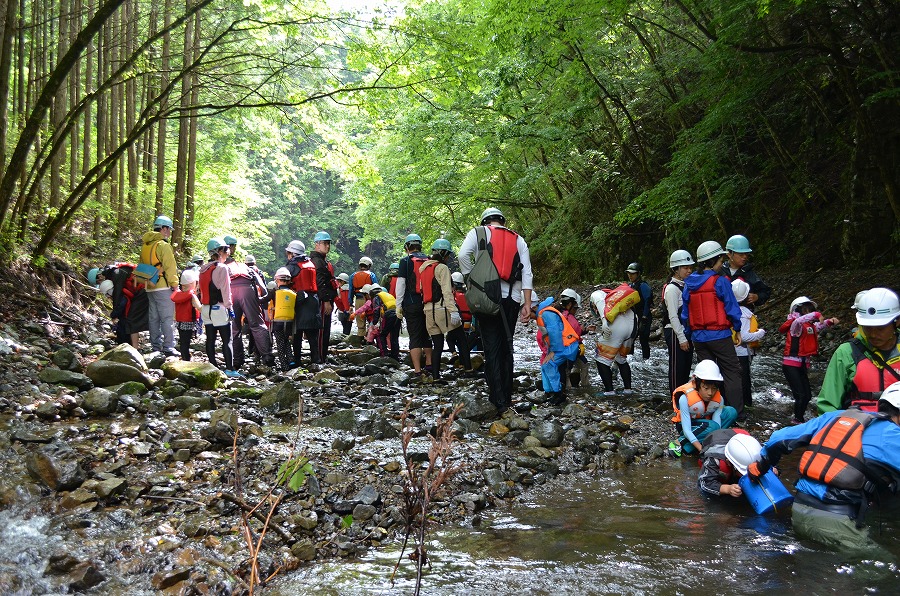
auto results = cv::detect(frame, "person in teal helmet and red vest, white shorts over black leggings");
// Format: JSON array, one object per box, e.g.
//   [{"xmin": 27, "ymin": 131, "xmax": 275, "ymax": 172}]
[{"xmin": 198, "ymin": 238, "xmax": 241, "ymax": 378}]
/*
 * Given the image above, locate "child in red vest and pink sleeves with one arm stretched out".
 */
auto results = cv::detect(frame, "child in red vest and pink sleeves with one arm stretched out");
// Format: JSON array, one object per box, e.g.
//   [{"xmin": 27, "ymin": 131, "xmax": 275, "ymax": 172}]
[{"xmin": 778, "ymin": 296, "xmax": 840, "ymax": 424}]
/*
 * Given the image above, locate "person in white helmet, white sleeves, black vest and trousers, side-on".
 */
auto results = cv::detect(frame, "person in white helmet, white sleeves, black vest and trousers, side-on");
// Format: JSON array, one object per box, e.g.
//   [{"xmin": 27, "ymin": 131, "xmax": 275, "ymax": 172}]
[{"xmin": 662, "ymin": 250, "xmax": 694, "ymax": 393}]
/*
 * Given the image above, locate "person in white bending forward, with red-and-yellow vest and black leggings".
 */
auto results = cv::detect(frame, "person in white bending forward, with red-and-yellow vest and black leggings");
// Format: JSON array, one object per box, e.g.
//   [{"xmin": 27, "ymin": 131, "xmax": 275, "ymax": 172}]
[{"xmin": 588, "ymin": 290, "xmax": 637, "ymax": 397}]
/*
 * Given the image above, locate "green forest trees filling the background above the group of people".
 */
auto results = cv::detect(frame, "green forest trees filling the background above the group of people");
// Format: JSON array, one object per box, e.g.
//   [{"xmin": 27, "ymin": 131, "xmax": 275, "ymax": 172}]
[{"xmin": 0, "ymin": 0, "xmax": 900, "ymax": 283}]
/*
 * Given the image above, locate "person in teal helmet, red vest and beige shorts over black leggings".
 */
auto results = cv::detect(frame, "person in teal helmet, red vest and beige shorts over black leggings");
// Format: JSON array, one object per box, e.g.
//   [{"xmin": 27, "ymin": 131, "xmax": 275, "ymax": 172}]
[{"xmin": 418, "ymin": 238, "xmax": 472, "ymax": 381}]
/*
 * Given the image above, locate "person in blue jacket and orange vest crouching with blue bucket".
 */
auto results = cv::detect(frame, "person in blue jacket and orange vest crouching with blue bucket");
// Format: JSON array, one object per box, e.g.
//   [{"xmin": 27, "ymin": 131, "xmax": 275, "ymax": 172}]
[{"xmin": 747, "ymin": 382, "xmax": 900, "ymax": 558}]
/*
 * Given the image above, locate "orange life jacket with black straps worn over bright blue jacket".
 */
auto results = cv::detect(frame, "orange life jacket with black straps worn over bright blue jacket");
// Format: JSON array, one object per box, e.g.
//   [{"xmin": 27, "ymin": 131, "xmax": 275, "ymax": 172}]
[{"xmin": 800, "ymin": 408, "xmax": 876, "ymax": 490}]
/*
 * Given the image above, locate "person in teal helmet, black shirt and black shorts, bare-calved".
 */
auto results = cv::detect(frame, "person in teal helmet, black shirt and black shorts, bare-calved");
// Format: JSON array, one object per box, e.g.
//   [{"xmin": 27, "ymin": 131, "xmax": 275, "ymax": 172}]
[{"xmin": 397, "ymin": 234, "xmax": 431, "ymax": 377}]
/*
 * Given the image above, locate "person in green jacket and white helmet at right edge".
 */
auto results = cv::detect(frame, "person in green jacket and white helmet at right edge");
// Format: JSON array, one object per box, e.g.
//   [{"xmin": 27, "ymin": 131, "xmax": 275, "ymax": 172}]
[{"xmin": 816, "ymin": 288, "xmax": 900, "ymax": 414}]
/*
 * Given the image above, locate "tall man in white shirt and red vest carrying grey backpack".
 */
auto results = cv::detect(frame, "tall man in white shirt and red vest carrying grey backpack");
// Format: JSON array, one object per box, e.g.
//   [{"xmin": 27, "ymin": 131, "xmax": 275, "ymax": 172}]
[{"xmin": 457, "ymin": 207, "xmax": 533, "ymax": 415}]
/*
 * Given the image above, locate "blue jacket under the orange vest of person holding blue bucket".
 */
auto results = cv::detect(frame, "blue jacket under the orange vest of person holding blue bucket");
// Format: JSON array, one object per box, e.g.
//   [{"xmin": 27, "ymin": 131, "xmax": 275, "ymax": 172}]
[{"xmin": 762, "ymin": 410, "xmax": 900, "ymax": 505}]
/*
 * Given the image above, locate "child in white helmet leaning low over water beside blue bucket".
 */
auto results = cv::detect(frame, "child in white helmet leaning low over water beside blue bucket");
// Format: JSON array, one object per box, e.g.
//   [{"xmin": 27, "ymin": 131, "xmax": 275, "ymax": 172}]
[{"xmin": 697, "ymin": 428, "xmax": 762, "ymax": 497}]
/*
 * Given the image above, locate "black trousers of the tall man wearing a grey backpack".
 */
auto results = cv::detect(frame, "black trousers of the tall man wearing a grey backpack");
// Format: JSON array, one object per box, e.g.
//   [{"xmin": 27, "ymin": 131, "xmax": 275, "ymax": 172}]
[{"xmin": 478, "ymin": 298, "xmax": 520, "ymax": 410}]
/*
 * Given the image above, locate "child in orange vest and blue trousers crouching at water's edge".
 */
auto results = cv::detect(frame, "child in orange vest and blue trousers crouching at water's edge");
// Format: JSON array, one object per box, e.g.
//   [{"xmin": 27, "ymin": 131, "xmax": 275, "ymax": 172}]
[{"xmin": 672, "ymin": 360, "xmax": 737, "ymax": 453}]
